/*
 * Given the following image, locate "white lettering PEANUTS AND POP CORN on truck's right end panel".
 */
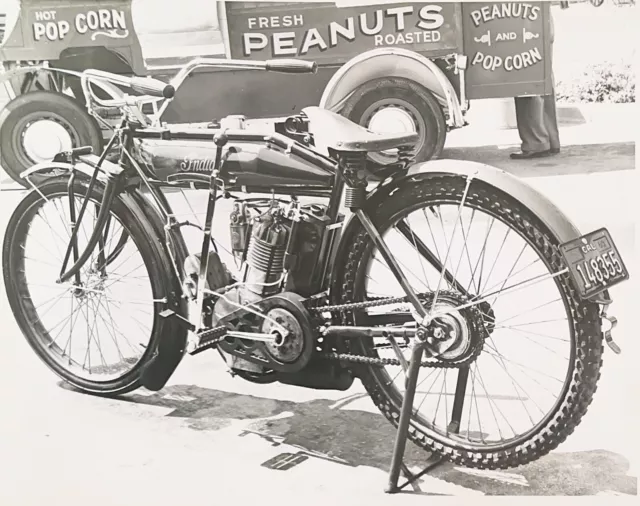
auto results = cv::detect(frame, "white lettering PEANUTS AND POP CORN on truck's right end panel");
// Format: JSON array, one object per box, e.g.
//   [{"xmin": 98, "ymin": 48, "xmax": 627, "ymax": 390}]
[{"xmin": 469, "ymin": 2, "xmax": 542, "ymax": 72}]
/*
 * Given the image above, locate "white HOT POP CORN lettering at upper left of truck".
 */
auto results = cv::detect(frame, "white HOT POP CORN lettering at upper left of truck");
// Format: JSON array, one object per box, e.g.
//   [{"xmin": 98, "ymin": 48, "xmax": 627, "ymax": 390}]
[{"xmin": 32, "ymin": 9, "xmax": 129, "ymax": 42}]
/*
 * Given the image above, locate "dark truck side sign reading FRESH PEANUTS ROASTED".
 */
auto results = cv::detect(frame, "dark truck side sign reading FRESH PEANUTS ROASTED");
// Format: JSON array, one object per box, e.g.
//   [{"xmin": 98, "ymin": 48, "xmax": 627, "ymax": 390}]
[{"xmin": 227, "ymin": 2, "xmax": 460, "ymax": 62}]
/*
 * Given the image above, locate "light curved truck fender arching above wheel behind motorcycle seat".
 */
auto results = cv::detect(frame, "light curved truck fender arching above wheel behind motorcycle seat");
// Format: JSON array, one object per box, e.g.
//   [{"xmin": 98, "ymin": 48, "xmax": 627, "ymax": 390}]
[{"xmin": 320, "ymin": 48, "xmax": 464, "ymax": 128}]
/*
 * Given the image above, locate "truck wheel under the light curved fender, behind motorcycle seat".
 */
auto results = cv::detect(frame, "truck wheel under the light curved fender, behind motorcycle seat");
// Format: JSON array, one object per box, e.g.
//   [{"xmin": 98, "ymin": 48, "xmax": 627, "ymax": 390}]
[{"xmin": 341, "ymin": 77, "xmax": 447, "ymax": 164}]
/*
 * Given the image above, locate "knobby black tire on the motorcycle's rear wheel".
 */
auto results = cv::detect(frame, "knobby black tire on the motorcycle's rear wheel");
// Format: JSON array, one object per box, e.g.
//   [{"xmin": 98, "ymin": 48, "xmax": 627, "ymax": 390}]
[{"xmin": 336, "ymin": 176, "xmax": 604, "ymax": 470}]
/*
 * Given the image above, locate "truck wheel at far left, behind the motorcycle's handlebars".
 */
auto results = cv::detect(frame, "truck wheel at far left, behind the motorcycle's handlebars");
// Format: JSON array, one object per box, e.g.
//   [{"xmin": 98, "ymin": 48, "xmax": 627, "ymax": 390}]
[{"xmin": 0, "ymin": 91, "xmax": 102, "ymax": 187}]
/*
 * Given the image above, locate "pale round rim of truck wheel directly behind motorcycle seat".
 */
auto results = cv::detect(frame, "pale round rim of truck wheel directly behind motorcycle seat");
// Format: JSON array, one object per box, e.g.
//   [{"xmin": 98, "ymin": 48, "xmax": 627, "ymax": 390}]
[{"xmin": 360, "ymin": 98, "xmax": 426, "ymax": 164}]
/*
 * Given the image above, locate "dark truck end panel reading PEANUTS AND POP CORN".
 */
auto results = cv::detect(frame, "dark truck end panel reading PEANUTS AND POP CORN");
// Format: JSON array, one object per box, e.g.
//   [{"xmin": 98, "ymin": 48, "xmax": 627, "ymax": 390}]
[{"xmin": 463, "ymin": 2, "xmax": 550, "ymax": 98}]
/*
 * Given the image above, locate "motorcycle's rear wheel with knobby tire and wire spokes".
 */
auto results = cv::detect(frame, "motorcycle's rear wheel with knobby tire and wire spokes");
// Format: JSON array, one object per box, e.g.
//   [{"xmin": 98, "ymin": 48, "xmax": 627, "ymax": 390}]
[{"xmin": 334, "ymin": 175, "xmax": 603, "ymax": 469}]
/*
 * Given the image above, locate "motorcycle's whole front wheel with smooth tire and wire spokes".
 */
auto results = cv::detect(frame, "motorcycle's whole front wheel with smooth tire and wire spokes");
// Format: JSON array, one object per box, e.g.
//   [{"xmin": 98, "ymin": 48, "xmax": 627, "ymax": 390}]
[{"xmin": 2, "ymin": 177, "xmax": 186, "ymax": 395}]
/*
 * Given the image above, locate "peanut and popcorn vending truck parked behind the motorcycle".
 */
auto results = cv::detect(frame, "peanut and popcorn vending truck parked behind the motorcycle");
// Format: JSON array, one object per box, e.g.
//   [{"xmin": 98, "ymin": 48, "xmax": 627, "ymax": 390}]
[{"xmin": 0, "ymin": 0, "xmax": 553, "ymax": 186}]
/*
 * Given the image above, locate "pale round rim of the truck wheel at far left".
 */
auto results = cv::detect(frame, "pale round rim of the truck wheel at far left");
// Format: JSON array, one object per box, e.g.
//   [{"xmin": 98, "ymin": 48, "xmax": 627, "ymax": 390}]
[{"xmin": 13, "ymin": 112, "xmax": 80, "ymax": 167}]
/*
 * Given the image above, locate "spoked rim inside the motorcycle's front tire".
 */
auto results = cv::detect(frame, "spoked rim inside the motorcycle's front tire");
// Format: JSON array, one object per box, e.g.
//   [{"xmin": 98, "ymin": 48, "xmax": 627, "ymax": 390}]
[{"xmin": 12, "ymin": 194, "xmax": 155, "ymax": 384}]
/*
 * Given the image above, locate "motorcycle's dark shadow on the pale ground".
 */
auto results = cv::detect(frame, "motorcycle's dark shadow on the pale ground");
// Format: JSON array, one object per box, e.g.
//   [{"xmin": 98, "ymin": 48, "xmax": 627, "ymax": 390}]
[{"xmin": 58, "ymin": 385, "xmax": 637, "ymax": 496}]
